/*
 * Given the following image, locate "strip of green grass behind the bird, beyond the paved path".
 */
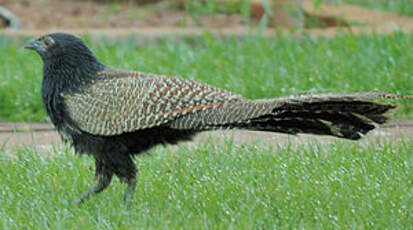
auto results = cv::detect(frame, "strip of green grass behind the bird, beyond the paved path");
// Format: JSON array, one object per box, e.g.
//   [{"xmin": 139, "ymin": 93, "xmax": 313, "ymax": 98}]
[{"xmin": 0, "ymin": 33, "xmax": 413, "ymax": 121}]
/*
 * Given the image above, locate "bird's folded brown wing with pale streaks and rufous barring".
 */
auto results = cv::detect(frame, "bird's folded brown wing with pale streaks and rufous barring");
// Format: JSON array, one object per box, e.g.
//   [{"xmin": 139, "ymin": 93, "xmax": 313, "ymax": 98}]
[{"xmin": 61, "ymin": 70, "xmax": 241, "ymax": 136}]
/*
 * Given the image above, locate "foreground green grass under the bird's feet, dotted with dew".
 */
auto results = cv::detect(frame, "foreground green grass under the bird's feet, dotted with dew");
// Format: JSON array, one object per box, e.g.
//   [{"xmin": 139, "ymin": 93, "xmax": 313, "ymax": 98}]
[{"xmin": 0, "ymin": 139, "xmax": 413, "ymax": 229}]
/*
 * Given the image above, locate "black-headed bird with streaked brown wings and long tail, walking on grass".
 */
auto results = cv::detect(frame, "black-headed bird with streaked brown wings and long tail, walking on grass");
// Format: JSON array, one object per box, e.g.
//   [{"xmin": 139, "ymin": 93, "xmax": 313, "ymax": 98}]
[{"xmin": 25, "ymin": 33, "xmax": 409, "ymax": 204}]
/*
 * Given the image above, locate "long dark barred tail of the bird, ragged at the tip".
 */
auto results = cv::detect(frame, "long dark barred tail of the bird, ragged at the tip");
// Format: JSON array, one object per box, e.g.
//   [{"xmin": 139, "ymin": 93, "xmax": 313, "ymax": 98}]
[{"xmin": 171, "ymin": 92, "xmax": 413, "ymax": 140}]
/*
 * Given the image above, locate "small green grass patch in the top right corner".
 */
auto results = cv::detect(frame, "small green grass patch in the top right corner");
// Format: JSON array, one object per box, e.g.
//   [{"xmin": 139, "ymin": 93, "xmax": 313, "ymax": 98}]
[{"xmin": 324, "ymin": 0, "xmax": 413, "ymax": 16}]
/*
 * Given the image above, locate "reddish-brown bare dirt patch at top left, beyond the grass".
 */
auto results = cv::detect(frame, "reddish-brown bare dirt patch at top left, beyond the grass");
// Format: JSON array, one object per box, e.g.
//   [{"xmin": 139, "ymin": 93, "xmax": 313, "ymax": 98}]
[{"xmin": 0, "ymin": 0, "xmax": 251, "ymax": 30}]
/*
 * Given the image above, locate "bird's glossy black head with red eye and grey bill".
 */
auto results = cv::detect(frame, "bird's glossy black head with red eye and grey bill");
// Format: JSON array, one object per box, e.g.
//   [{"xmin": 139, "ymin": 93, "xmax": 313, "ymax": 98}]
[{"xmin": 25, "ymin": 33, "xmax": 105, "ymax": 91}]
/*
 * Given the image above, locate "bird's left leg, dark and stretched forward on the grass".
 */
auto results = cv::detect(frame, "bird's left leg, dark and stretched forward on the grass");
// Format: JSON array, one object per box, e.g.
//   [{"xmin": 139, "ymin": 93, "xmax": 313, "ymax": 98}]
[{"xmin": 74, "ymin": 160, "xmax": 113, "ymax": 204}]
